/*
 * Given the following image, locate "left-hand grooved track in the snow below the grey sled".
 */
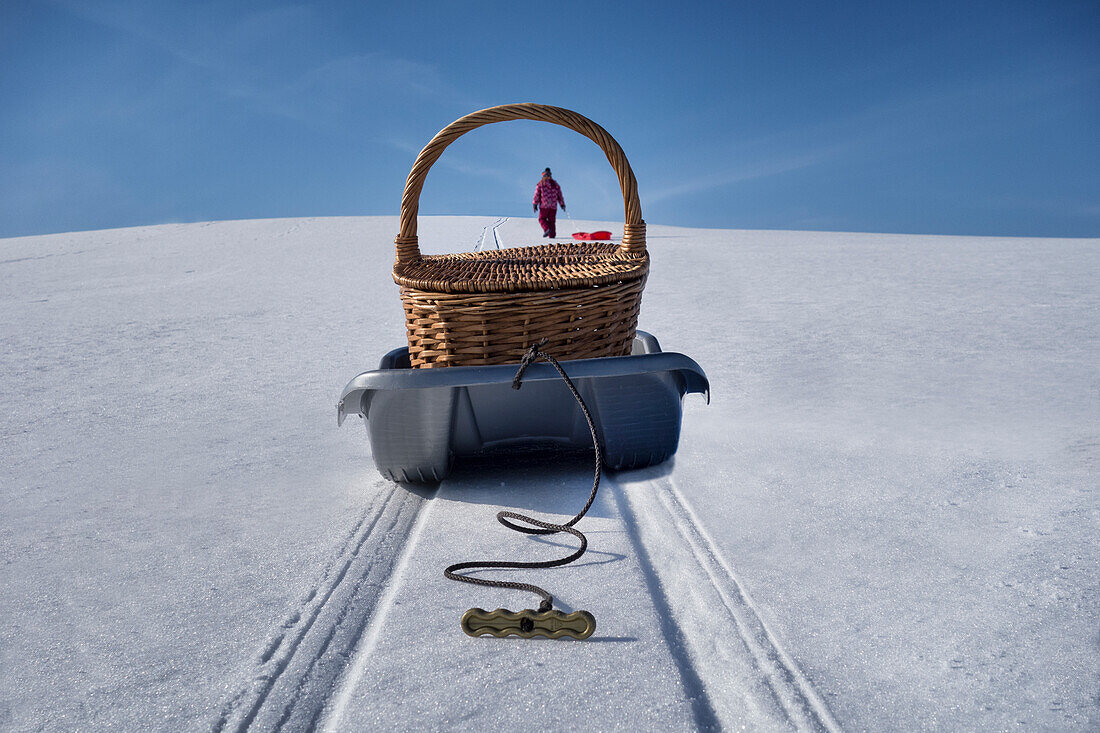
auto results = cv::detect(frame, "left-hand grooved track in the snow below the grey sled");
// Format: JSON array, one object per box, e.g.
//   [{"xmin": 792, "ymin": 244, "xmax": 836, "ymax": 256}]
[{"xmin": 212, "ymin": 484, "xmax": 425, "ymax": 733}]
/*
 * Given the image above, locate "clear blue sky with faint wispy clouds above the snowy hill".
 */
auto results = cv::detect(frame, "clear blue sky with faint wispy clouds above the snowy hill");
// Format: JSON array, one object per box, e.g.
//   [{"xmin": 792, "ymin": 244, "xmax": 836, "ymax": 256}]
[{"xmin": 0, "ymin": 0, "xmax": 1100, "ymax": 237}]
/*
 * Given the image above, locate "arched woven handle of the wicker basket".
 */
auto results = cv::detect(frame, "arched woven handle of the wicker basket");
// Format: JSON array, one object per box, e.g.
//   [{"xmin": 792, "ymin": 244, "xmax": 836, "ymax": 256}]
[{"xmin": 394, "ymin": 102, "xmax": 646, "ymax": 264}]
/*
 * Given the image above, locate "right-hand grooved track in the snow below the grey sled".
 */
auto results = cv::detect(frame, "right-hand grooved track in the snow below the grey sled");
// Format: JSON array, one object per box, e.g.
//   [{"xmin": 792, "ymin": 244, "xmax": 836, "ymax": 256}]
[{"xmin": 607, "ymin": 469, "xmax": 840, "ymax": 733}]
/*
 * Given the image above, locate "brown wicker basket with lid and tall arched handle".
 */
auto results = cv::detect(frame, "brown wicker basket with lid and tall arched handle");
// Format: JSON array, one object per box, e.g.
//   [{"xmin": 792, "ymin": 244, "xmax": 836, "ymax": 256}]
[{"xmin": 394, "ymin": 103, "xmax": 649, "ymax": 369}]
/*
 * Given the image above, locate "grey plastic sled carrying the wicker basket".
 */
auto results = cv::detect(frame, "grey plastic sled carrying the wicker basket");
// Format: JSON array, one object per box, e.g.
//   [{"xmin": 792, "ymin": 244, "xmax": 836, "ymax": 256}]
[{"xmin": 337, "ymin": 331, "xmax": 711, "ymax": 483}]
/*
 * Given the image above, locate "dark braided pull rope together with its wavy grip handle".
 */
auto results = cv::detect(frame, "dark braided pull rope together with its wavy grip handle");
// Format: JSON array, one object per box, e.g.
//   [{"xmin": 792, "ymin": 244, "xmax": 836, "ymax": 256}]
[{"xmin": 443, "ymin": 339, "xmax": 603, "ymax": 638}]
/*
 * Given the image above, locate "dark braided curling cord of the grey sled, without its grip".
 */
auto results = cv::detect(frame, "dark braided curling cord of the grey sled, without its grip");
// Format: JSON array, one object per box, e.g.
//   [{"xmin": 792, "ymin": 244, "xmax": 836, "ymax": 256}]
[{"xmin": 443, "ymin": 339, "xmax": 603, "ymax": 612}]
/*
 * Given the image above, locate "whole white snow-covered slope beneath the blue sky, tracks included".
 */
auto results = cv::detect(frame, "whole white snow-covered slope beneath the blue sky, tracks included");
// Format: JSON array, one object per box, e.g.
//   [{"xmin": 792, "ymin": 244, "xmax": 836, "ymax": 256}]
[{"xmin": 0, "ymin": 217, "xmax": 1100, "ymax": 731}]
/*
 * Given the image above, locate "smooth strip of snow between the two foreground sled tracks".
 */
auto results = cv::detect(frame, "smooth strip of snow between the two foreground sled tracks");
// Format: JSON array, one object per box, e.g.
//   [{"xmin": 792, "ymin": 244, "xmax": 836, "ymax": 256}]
[{"xmin": 329, "ymin": 466, "xmax": 692, "ymax": 730}]
